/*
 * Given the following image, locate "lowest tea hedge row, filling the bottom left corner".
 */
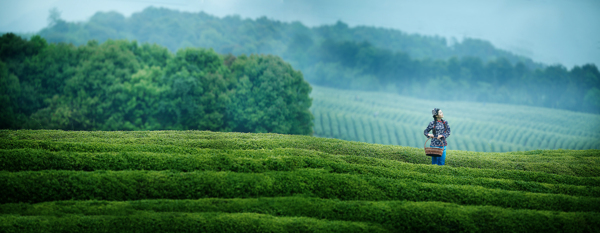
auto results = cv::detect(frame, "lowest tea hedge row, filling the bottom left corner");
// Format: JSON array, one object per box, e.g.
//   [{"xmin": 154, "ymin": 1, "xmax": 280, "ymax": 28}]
[{"xmin": 0, "ymin": 211, "xmax": 387, "ymax": 232}]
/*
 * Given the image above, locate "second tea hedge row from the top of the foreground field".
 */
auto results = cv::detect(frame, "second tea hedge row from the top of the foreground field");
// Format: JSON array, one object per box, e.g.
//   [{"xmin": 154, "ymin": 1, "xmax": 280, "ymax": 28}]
[{"xmin": 0, "ymin": 149, "xmax": 600, "ymax": 197}]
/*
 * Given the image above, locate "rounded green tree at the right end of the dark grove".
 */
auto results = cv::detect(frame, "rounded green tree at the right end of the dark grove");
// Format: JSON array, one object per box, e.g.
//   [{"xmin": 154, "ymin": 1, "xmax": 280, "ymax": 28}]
[{"xmin": 228, "ymin": 55, "xmax": 313, "ymax": 135}]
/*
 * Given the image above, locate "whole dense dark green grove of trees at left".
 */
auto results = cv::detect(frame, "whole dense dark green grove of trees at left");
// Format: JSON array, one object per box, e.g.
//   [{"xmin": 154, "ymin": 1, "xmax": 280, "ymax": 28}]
[{"xmin": 0, "ymin": 33, "xmax": 313, "ymax": 135}]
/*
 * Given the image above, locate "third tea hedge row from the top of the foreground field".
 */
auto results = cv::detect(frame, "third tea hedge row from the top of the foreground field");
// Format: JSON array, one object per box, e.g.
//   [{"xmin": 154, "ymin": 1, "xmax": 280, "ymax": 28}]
[{"xmin": 0, "ymin": 169, "xmax": 600, "ymax": 212}]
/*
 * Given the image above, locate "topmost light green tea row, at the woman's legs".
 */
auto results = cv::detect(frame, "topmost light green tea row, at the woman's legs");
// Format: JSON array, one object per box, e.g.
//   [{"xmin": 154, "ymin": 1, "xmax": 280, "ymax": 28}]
[{"xmin": 0, "ymin": 131, "xmax": 598, "ymax": 177}]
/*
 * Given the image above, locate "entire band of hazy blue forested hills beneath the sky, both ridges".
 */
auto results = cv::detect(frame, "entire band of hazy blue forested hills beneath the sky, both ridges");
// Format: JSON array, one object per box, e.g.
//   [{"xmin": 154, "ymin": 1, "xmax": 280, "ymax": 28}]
[{"xmin": 23, "ymin": 7, "xmax": 600, "ymax": 113}]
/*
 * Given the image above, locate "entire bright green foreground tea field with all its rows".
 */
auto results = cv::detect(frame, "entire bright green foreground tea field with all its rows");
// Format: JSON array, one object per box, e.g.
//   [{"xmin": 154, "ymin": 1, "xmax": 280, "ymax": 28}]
[{"xmin": 0, "ymin": 130, "xmax": 600, "ymax": 233}]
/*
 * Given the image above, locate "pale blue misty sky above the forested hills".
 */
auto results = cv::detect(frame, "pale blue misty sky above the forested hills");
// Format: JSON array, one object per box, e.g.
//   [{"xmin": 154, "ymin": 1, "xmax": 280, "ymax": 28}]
[{"xmin": 0, "ymin": 0, "xmax": 600, "ymax": 68}]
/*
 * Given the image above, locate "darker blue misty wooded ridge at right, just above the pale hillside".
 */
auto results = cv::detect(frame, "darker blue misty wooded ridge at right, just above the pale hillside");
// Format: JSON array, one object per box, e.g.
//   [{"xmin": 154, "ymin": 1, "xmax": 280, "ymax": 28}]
[{"xmin": 305, "ymin": 40, "xmax": 600, "ymax": 113}]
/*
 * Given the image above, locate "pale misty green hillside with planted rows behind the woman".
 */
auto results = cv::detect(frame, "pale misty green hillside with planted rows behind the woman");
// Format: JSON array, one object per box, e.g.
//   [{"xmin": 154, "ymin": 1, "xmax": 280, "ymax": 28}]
[{"xmin": 311, "ymin": 86, "xmax": 600, "ymax": 152}]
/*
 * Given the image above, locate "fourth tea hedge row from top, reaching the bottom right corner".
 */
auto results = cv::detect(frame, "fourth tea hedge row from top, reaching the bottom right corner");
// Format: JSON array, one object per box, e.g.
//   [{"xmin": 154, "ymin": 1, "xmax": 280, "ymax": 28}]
[{"xmin": 0, "ymin": 197, "xmax": 600, "ymax": 232}]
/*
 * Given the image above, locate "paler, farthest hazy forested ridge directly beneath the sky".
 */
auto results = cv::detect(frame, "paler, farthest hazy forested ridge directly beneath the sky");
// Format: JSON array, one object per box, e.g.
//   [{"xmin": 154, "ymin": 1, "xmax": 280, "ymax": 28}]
[{"xmin": 39, "ymin": 7, "xmax": 542, "ymax": 68}]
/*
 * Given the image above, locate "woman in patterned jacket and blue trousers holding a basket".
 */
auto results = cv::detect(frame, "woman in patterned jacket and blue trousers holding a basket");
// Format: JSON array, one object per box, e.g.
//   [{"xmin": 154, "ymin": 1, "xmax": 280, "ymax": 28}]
[{"xmin": 423, "ymin": 108, "xmax": 450, "ymax": 166}]
